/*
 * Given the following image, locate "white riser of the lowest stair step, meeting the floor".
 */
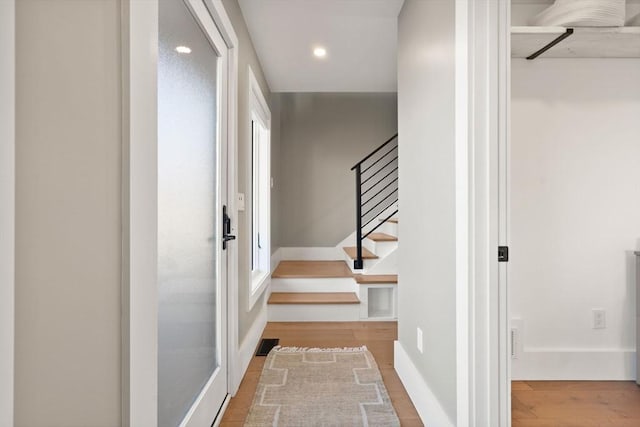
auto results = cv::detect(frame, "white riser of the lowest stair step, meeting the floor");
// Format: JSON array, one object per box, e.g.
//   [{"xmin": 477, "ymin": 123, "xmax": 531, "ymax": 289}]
[{"xmin": 267, "ymin": 304, "xmax": 360, "ymax": 322}]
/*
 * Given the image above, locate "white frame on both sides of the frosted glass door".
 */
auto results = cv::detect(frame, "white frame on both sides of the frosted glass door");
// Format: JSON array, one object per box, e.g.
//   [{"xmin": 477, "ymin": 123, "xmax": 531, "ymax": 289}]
[{"xmin": 122, "ymin": 0, "xmax": 240, "ymax": 427}]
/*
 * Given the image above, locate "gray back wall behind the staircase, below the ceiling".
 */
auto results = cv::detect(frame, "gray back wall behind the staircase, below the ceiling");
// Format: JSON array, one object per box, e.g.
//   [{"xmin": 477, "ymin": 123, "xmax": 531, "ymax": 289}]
[{"xmin": 273, "ymin": 93, "xmax": 398, "ymax": 247}]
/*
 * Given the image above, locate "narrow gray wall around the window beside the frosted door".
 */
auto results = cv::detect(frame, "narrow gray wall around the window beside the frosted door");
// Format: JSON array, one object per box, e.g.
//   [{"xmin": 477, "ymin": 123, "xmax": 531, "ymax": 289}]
[{"xmin": 222, "ymin": 0, "xmax": 271, "ymax": 343}]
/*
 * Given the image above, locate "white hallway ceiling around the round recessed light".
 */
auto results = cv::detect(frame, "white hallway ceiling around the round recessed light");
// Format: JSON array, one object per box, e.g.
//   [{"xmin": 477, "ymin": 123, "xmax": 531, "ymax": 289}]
[{"xmin": 239, "ymin": 0, "xmax": 404, "ymax": 92}]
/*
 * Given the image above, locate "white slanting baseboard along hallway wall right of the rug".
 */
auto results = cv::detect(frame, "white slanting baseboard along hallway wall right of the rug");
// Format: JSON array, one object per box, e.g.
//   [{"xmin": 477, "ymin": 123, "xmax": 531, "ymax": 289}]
[{"xmin": 393, "ymin": 341, "xmax": 455, "ymax": 427}]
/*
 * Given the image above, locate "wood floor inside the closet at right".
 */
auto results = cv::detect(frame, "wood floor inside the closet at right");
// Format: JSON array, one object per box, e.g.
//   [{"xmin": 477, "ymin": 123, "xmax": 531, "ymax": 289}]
[{"xmin": 511, "ymin": 381, "xmax": 640, "ymax": 427}]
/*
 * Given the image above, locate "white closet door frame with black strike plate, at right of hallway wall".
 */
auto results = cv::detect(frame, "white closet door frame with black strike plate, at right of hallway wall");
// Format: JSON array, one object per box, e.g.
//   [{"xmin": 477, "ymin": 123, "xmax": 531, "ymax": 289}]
[{"xmin": 456, "ymin": 0, "xmax": 511, "ymax": 427}]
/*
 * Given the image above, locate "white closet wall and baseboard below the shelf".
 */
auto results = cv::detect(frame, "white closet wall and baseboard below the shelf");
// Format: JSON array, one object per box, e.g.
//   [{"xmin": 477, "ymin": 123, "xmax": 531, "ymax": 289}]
[{"xmin": 509, "ymin": 59, "xmax": 640, "ymax": 379}]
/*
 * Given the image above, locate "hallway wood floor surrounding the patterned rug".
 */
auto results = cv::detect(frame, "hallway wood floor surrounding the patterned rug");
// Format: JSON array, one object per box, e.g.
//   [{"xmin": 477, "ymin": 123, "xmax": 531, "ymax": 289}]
[{"xmin": 221, "ymin": 322, "xmax": 422, "ymax": 427}]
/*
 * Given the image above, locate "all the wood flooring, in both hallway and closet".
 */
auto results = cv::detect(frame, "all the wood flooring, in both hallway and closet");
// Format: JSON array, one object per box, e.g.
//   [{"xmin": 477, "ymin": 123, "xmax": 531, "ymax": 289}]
[{"xmin": 216, "ymin": 322, "xmax": 640, "ymax": 427}]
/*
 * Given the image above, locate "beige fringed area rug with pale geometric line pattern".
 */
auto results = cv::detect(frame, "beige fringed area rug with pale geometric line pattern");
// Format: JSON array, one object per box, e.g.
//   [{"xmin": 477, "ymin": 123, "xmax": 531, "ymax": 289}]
[{"xmin": 245, "ymin": 346, "xmax": 400, "ymax": 427}]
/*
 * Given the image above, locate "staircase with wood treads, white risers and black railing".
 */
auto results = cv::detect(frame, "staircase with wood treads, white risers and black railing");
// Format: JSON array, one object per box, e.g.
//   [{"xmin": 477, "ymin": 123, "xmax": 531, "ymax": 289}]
[{"xmin": 268, "ymin": 135, "xmax": 398, "ymax": 321}]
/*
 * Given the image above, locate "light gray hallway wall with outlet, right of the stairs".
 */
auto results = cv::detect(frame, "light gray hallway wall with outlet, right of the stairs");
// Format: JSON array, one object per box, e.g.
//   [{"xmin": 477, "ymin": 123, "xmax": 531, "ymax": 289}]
[{"xmin": 398, "ymin": 0, "xmax": 456, "ymax": 424}]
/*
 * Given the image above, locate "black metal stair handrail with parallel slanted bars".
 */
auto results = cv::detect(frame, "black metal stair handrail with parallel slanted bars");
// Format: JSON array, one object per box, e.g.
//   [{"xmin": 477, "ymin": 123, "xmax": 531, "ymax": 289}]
[{"xmin": 351, "ymin": 134, "xmax": 398, "ymax": 269}]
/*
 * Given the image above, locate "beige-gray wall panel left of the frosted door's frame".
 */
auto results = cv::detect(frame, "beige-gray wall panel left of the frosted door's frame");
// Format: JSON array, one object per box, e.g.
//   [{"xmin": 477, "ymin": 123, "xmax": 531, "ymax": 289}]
[{"xmin": 15, "ymin": 0, "xmax": 121, "ymax": 427}]
